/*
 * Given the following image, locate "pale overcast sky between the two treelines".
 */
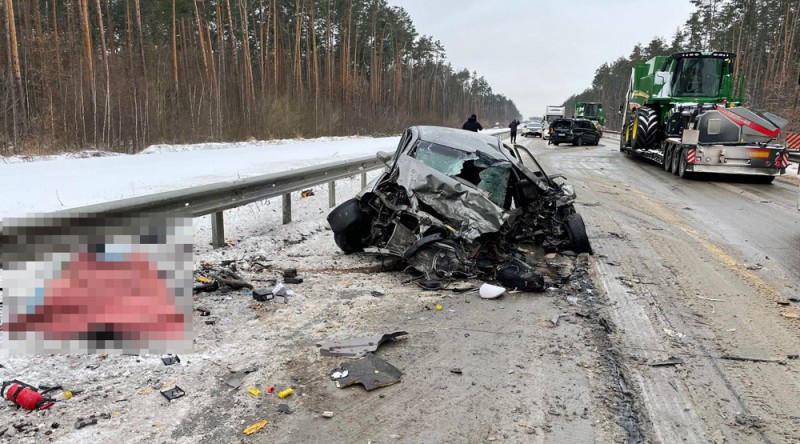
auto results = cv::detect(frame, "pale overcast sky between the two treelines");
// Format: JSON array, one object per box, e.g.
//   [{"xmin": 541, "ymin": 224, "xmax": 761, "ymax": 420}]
[{"xmin": 389, "ymin": 0, "xmax": 694, "ymax": 119}]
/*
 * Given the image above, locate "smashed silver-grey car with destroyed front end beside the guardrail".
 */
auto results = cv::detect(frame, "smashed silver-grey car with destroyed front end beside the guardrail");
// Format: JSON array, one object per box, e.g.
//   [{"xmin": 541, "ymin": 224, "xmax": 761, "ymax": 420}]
[{"xmin": 328, "ymin": 126, "xmax": 591, "ymax": 291}]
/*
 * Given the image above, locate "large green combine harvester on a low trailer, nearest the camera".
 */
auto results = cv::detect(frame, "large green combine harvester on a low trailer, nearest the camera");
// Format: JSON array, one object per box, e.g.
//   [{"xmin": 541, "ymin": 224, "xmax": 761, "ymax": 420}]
[{"xmin": 620, "ymin": 51, "xmax": 789, "ymax": 183}]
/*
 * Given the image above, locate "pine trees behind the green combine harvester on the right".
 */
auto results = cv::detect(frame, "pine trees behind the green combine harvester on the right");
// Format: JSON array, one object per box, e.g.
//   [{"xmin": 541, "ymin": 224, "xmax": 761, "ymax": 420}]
[{"xmin": 564, "ymin": 0, "xmax": 800, "ymax": 131}]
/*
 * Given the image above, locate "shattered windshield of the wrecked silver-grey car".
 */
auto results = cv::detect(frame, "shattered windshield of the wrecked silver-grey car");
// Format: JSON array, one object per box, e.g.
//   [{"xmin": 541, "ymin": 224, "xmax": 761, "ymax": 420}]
[{"xmin": 409, "ymin": 140, "xmax": 511, "ymax": 207}]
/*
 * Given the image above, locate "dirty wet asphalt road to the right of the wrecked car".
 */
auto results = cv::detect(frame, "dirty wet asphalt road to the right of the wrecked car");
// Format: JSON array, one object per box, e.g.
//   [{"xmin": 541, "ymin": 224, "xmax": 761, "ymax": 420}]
[{"xmin": 521, "ymin": 134, "xmax": 800, "ymax": 443}]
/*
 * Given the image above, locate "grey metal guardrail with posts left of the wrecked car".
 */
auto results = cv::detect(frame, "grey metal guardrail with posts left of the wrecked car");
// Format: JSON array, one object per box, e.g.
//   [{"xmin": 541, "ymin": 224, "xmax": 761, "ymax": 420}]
[{"xmin": 54, "ymin": 155, "xmax": 384, "ymax": 248}]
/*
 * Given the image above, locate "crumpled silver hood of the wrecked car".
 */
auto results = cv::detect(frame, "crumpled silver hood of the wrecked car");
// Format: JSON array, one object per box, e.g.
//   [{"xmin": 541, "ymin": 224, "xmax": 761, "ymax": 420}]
[{"xmin": 397, "ymin": 156, "xmax": 506, "ymax": 241}]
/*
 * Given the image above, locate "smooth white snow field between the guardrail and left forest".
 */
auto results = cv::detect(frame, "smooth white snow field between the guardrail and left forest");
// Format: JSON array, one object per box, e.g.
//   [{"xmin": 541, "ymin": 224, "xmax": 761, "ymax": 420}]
[{"xmin": 0, "ymin": 129, "xmax": 505, "ymax": 219}]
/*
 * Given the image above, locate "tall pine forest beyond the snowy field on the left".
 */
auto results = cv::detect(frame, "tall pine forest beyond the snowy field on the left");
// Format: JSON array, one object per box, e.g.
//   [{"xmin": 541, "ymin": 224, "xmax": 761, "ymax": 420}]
[{"xmin": 0, "ymin": 0, "xmax": 519, "ymax": 154}]
